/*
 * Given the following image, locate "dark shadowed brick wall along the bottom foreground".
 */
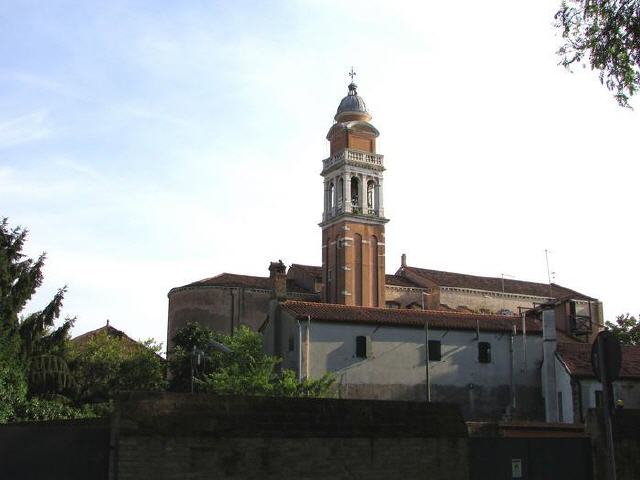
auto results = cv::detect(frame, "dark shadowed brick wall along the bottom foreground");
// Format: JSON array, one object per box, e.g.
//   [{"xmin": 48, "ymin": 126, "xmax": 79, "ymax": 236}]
[{"xmin": 117, "ymin": 394, "xmax": 468, "ymax": 480}]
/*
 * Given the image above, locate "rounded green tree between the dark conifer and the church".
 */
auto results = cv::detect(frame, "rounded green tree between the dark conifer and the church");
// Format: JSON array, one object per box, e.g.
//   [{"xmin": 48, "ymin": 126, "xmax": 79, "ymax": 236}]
[{"xmin": 69, "ymin": 331, "xmax": 166, "ymax": 404}]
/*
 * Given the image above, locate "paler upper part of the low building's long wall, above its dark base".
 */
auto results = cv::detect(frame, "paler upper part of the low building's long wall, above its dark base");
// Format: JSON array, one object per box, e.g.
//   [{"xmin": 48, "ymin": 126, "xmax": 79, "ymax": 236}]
[{"xmin": 288, "ymin": 322, "xmax": 542, "ymax": 387}]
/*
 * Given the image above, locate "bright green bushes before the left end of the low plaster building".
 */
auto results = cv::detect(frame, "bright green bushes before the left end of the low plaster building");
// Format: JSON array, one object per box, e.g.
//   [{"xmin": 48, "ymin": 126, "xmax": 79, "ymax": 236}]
[{"xmin": 169, "ymin": 323, "xmax": 333, "ymax": 397}]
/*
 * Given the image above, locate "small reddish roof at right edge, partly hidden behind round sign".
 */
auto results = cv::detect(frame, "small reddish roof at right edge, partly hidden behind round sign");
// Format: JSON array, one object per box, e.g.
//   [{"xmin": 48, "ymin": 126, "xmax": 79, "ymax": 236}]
[{"xmin": 556, "ymin": 343, "xmax": 640, "ymax": 379}]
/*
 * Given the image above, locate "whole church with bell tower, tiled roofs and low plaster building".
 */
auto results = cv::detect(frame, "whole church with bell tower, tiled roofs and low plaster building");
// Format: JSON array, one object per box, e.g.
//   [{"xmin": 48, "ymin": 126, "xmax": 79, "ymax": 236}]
[{"xmin": 167, "ymin": 76, "xmax": 602, "ymax": 419}]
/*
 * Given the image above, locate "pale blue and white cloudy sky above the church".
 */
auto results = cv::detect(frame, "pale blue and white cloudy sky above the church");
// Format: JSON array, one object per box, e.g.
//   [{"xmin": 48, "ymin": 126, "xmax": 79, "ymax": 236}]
[{"xmin": 0, "ymin": 0, "xmax": 640, "ymax": 341}]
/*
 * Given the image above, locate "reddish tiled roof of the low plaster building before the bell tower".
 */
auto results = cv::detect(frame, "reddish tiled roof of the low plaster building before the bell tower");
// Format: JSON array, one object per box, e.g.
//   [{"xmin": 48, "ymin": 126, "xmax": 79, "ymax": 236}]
[{"xmin": 282, "ymin": 300, "xmax": 542, "ymax": 333}]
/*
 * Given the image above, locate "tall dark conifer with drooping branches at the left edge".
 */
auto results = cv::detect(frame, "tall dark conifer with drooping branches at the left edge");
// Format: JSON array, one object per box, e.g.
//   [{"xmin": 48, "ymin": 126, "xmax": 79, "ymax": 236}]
[{"xmin": 0, "ymin": 218, "xmax": 78, "ymax": 422}]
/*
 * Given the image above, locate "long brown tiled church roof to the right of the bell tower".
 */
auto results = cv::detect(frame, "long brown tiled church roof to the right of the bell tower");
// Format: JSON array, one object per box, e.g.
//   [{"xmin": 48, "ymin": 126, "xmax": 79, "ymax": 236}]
[{"xmin": 396, "ymin": 266, "xmax": 595, "ymax": 300}]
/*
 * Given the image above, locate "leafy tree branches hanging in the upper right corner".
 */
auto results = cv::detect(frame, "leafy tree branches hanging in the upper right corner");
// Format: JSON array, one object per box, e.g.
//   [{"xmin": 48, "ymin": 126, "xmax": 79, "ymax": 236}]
[{"xmin": 555, "ymin": 0, "xmax": 640, "ymax": 107}]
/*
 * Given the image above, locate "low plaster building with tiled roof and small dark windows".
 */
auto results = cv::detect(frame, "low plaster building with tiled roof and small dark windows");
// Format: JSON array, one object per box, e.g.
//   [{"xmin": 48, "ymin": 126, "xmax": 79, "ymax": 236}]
[{"xmin": 261, "ymin": 300, "xmax": 544, "ymax": 419}]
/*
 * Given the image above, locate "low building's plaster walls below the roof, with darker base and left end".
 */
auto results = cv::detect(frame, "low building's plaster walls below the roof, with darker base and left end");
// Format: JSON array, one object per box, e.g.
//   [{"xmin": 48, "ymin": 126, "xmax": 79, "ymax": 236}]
[{"xmin": 281, "ymin": 314, "xmax": 543, "ymax": 419}]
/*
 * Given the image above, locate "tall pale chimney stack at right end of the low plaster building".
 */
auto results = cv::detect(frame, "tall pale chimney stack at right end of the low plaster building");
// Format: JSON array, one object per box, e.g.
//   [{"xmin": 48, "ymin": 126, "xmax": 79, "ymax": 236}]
[{"xmin": 542, "ymin": 305, "xmax": 558, "ymax": 423}]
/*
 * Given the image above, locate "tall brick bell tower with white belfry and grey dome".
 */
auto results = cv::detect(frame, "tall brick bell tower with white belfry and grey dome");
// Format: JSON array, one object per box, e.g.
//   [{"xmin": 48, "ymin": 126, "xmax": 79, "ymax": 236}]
[{"xmin": 320, "ymin": 75, "xmax": 388, "ymax": 307}]
